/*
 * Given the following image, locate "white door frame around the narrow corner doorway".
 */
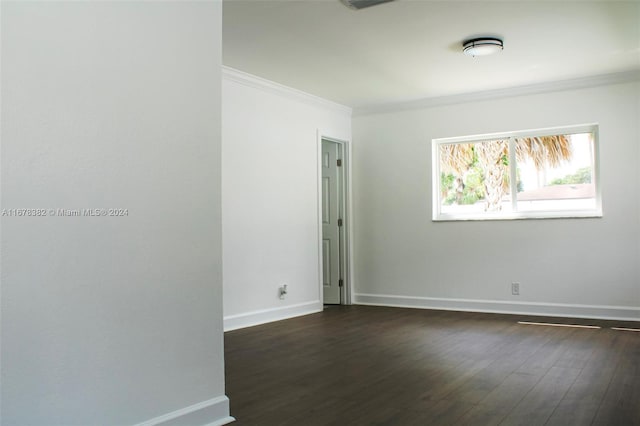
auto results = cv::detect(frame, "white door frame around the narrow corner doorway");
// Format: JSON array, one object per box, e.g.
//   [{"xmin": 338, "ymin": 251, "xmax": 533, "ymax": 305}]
[{"xmin": 316, "ymin": 129, "xmax": 353, "ymax": 305}]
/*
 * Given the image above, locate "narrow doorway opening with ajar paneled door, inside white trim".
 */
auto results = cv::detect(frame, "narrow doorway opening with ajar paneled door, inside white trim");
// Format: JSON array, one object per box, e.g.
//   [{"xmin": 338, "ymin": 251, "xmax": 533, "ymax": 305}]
[{"xmin": 320, "ymin": 138, "xmax": 348, "ymax": 305}]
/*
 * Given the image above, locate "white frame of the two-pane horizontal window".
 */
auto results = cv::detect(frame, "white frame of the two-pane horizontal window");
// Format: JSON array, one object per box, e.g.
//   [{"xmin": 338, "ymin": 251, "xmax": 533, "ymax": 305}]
[{"xmin": 431, "ymin": 123, "xmax": 602, "ymax": 222}]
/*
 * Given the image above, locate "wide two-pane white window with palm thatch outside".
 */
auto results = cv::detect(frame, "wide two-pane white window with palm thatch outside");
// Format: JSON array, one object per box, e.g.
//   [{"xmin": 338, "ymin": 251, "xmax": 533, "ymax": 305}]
[{"xmin": 432, "ymin": 124, "xmax": 602, "ymax": 220}]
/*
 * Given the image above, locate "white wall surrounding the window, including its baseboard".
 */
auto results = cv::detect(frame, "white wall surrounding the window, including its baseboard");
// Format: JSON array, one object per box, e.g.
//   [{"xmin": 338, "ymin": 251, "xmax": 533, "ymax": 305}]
[{"xmin": 353, "ymin": 83, "xmax": 640, "ymax": 319}]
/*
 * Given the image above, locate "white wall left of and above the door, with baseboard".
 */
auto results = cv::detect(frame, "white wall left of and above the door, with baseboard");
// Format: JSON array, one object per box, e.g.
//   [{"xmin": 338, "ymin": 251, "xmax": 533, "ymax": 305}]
[{"xmin": 222, "ymin": 69, "xmax": 351, "ymax": 329}]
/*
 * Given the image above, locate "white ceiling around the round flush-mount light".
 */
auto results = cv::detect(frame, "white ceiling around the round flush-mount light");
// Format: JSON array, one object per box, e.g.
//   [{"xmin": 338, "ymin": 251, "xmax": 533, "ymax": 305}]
[{"xmin": 223, "ymin": 0, "xmax": 640, "ymax": 108}]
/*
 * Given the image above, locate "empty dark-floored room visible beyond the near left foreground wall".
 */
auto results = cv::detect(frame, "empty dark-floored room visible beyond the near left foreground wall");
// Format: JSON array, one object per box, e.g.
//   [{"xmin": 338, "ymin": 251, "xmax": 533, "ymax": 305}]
[{"xmin": 222, "ymin": 0, "xmax": 640, "ymax": 425}]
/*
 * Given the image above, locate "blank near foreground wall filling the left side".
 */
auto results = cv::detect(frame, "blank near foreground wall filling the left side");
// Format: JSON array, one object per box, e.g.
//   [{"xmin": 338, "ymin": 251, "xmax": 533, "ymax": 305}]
[{"xmin": 1, "ymin": 1, "xmax": 231, "ymax": 425}]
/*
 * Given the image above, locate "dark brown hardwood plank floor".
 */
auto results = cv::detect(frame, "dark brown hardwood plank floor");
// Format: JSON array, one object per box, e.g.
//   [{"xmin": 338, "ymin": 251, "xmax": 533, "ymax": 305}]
[{"xmin": 225, "ymin": 306, "xmax": 640, "ymax": 426}]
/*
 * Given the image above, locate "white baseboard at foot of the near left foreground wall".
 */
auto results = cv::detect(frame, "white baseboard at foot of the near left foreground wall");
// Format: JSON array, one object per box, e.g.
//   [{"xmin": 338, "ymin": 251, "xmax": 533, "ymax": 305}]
[{"xmin": 135, "ymin": 395, "xmax": 236, "ymax": 426}]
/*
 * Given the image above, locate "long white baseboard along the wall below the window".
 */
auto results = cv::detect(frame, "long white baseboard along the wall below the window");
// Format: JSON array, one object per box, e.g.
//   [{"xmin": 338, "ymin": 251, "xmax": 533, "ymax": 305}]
[{"xmin": 353, "ymin": 294, "xmax": 640, "ymax": 321}]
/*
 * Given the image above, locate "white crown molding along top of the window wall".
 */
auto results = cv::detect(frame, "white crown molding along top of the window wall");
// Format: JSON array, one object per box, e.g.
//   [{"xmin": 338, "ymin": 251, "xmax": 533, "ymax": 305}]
[{"xmin": 353, "ymin": 70, "xmax": 640, "ymax": 117}]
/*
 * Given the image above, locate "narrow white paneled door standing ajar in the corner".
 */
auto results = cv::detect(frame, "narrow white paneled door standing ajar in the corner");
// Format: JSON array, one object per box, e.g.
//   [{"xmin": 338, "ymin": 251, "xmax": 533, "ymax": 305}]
[{"xmin": 322, "ymin": 140, "xmax": 343, "ymax": 304}]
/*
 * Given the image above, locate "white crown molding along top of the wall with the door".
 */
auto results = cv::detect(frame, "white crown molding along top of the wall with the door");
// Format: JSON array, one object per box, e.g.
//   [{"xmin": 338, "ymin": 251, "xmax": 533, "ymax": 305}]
[{"xmin": 222, "ymin": 65, "xmax": 353, "ymax": 116}]
